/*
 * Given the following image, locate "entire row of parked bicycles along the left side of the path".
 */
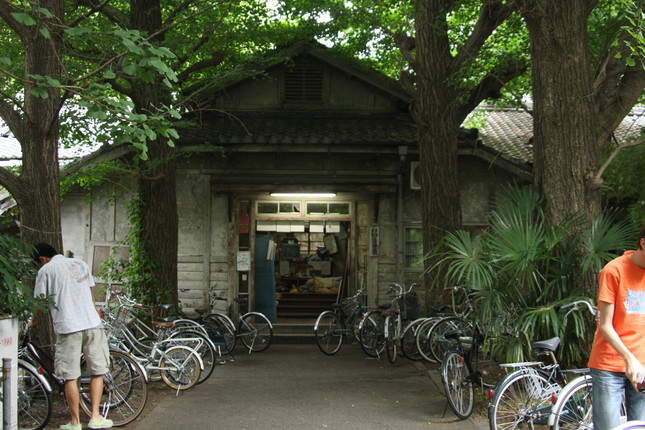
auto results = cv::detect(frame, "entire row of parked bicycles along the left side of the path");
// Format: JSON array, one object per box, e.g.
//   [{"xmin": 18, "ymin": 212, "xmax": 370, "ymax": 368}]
[{"xmin": 18, "ymin": 290, "xmax": 273, "ymax": 430}]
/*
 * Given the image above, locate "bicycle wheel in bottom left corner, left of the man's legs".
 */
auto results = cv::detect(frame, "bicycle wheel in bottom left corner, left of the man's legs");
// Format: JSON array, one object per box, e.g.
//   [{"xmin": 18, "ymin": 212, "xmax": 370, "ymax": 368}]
[{"xmin": 17, "ymin": 360, "xmax": 52, "ymax": 430}]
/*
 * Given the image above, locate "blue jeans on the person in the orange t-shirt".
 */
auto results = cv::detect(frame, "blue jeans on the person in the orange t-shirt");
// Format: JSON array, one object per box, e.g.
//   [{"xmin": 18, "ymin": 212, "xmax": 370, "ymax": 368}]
[{"xmin": 591, "ymin": 369, "xmax": 645, "ymax": 430}]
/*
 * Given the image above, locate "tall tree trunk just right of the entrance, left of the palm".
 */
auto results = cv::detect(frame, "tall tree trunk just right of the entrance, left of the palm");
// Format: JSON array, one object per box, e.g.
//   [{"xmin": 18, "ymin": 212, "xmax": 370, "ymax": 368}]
[{"xmin": 412, "ymin": 1, "xmax": 461, "ymax": 306}]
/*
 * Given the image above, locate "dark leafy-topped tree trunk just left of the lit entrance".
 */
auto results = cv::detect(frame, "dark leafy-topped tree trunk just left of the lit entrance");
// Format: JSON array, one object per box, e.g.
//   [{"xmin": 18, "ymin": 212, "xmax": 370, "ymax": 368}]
[{"xmin": 131, "ymin": 0, "xmax": 179, "ymax": 310}]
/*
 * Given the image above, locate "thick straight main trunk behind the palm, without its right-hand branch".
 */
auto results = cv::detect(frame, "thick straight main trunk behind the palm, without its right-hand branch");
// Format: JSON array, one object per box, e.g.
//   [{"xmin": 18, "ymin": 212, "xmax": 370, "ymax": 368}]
[{"xmin": 523, "ymin": 0, "xmax": 601, "ymax": 293}]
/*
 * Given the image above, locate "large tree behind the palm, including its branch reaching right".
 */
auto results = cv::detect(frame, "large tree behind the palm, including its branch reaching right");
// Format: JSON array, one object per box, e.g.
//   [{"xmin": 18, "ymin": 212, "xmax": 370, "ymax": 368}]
[{"xmin": 521, "ymin": 0, "xmax": 645, "ymax": 292}]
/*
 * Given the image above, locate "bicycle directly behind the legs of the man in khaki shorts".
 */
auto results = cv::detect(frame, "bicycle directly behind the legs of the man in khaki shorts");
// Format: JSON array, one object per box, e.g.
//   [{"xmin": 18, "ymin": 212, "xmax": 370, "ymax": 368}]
[{"xmin": 17, "ymin": 328, "xmax": 148, "ymax": 430}]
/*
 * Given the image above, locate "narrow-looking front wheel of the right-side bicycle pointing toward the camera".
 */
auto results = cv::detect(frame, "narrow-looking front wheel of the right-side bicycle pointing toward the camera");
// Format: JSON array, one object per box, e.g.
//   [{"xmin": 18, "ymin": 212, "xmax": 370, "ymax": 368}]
[{"xmin": 441, "ymin": 350, "xmax": 475, "ymax": 420}]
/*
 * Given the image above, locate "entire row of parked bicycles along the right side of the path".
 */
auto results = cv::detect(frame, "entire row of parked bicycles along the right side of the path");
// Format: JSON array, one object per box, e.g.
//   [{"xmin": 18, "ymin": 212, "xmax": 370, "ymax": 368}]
[{"xmin": 314, "ymin": 284, "xmax": 640, "ymax": 430}]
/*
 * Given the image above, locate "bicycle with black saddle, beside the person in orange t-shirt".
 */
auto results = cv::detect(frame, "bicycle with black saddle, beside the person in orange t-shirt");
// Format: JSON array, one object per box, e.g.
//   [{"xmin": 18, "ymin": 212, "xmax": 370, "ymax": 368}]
[{"xmin": 488, "ymin": 300, "xmax": 595, "ymax": 430}]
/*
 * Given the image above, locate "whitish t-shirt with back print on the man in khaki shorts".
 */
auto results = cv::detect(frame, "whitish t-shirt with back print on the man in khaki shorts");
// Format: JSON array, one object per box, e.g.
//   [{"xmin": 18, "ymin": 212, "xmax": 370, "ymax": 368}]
[{"xmin": 34, "ymin": 255, "xmax": 101, "ymax": 334}]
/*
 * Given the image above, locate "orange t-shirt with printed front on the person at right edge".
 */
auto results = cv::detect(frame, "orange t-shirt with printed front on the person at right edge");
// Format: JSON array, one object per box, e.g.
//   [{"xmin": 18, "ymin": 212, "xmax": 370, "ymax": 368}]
[{"xmin": 588, "ymin": 251, "xmax": 645, "ymax": 372}]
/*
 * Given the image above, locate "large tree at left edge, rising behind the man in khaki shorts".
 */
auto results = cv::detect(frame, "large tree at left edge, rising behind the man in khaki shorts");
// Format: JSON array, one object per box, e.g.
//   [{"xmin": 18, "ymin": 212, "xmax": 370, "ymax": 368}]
[{"xmin": 0, "ymin": 0, "xmax": 65, "ymax": 250}]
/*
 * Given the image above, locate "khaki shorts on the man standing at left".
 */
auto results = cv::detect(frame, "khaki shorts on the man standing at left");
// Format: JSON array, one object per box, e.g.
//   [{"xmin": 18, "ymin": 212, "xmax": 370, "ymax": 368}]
[{"xmin": 55, "ymin": 328, "xmax": 110, "ymax": 381}]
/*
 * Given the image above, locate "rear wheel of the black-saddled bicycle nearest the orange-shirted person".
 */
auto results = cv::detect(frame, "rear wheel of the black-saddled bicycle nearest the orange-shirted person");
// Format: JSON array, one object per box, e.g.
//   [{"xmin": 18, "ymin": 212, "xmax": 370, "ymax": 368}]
[{"xmin": 488, "ymin": 368, "xmax": 561, "ymax": 430}]
